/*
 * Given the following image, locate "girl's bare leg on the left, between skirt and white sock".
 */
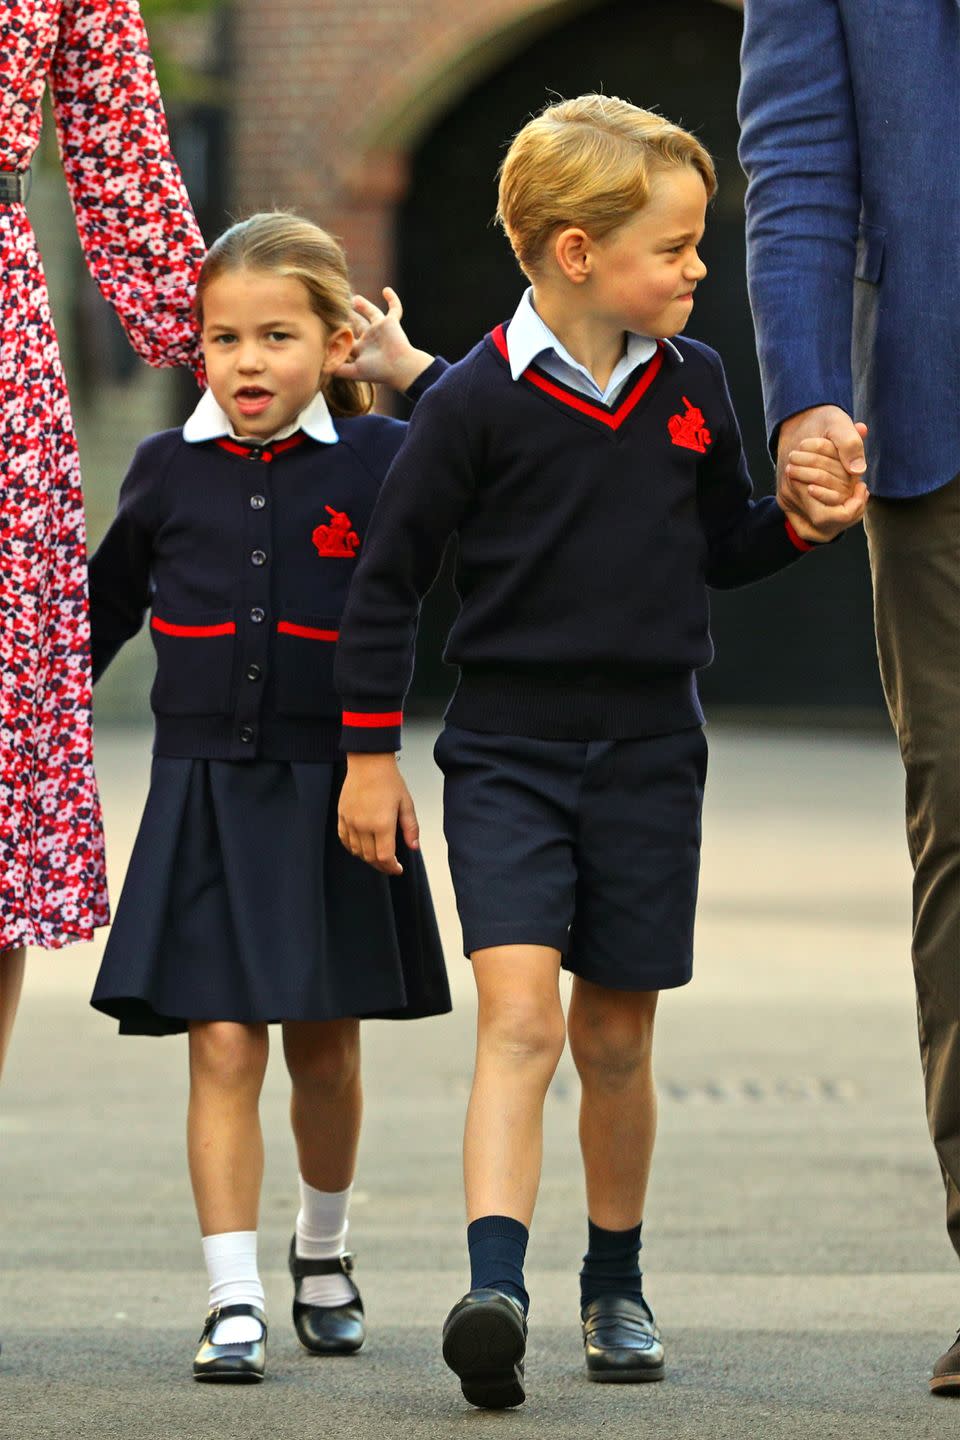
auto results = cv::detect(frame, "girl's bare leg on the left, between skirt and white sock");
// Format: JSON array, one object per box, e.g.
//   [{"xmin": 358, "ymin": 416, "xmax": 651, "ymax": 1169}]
[{"xmin": 187, "ymin": 1021, "xmax": 269, "ymax": 1236}]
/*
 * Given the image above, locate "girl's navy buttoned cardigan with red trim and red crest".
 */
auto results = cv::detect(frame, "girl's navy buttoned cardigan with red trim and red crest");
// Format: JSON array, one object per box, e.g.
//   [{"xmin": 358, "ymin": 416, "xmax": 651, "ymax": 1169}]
[{"xmin": 89, "ymin": 361, "xmax": 445, "ymax": 760}]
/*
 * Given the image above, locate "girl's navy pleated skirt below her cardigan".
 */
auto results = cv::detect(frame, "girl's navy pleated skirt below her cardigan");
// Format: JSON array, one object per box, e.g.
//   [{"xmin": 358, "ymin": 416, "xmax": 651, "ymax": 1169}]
[{"xmin": 91, "ymin": 756, "xmax": 450, "ymax": 1035}]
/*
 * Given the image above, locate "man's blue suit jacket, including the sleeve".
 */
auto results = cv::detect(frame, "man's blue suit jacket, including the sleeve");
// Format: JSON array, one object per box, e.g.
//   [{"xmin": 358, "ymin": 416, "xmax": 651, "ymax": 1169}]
[{"xmin": 740, "ymin": 0, "xmax": 960, "ymax": 497}]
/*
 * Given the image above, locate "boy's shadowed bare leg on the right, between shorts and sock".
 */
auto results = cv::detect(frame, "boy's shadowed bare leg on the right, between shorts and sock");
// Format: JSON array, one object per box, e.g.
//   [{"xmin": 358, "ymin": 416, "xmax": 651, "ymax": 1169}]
[{"xmin": 567, "ymin": 976, "xmax": 658, "ymax": 1230}]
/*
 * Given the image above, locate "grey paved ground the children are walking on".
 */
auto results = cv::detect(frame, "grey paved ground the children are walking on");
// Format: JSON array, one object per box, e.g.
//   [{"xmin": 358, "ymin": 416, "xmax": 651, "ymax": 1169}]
[{"xmin": 0, "ymin": 727, "xmax": 960, "ymax": 1440}]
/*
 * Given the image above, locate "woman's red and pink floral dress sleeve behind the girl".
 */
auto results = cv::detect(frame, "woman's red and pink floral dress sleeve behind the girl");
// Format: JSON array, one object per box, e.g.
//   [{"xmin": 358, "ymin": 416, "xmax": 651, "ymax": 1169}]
[{"xmin": 49, "ymin": 0, "xmax": 204, "ymax": 370}]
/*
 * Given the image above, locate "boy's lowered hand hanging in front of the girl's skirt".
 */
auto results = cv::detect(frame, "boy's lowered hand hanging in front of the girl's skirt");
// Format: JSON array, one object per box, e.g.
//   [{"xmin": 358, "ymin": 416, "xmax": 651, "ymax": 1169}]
[{"xmin": 337, "ymin": 755, "xmax": 420, "ymax": 876}]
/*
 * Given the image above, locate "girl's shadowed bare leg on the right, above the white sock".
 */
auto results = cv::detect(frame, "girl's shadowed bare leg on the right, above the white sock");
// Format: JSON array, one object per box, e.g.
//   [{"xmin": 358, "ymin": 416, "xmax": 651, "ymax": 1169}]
[{"xmin": 284, "ymin": 1020, "xmax": 363, "ymax": 1191}]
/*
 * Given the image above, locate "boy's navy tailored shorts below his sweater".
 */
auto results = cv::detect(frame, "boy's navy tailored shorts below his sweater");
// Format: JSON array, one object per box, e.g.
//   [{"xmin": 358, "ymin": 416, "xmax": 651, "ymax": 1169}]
[{"xmin": 433, "ymin": 726, "xmax": 707, "ymax": 991}]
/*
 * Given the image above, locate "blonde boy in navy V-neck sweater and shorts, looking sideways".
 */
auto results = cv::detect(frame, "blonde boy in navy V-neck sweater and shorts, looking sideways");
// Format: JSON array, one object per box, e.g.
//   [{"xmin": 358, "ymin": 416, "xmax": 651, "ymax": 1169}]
[{"xmin": 337, "ymin": 95, "xmax": 864, "ymax": 1408}]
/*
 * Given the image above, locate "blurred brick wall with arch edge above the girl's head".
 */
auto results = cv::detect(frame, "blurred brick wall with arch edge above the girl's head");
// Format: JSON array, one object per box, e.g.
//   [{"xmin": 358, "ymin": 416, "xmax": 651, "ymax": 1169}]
[{"xmin": 230, "ymin": 0, "xmax": 743, "ymax": 294}]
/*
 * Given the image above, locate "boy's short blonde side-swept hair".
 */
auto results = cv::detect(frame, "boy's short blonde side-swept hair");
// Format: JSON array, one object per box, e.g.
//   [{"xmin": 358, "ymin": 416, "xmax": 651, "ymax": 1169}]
[{"xmin": 497, "ymin": 95, "xmax": 717, "ymax": 275}]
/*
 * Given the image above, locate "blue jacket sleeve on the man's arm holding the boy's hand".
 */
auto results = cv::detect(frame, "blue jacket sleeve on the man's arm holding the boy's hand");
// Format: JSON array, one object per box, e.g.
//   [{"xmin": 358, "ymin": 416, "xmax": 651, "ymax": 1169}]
[{"xmin": 738, "ymin": 0, "xmax": 861, "ymax": 452}]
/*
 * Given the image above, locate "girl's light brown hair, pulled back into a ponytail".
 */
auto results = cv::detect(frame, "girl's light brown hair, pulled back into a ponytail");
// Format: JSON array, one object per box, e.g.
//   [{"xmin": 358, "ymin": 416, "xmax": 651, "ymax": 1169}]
[{"xmin": 194, "ymin": 210, "xmax": 373, "ymax": 416}]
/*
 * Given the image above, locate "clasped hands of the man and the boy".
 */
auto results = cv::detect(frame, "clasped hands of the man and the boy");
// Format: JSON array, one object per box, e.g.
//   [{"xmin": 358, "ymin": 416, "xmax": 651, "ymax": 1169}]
[{"xmin": 777, "ymin": 405, "xmax": 869, "ymax": 543}]
